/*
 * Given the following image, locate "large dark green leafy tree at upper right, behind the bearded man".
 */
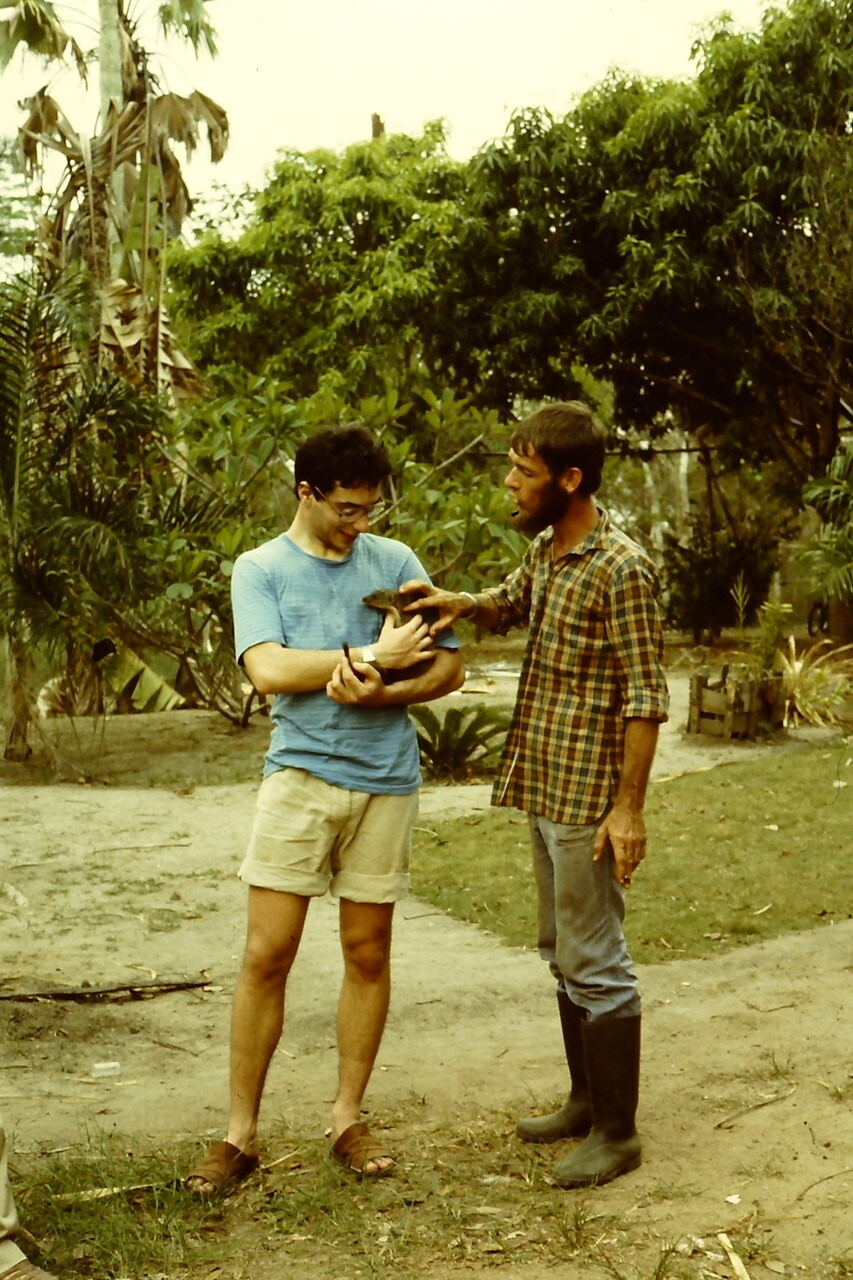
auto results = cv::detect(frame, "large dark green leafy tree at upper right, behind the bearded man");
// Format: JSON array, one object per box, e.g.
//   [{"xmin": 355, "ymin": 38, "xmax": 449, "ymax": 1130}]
[{"xmin": 446, "ymin": 0, "xmax": 853, "ymax": 477}]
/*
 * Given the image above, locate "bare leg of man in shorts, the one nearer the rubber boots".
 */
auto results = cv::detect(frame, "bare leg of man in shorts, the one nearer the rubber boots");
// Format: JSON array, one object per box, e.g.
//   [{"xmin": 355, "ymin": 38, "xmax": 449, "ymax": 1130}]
[{"xmin": 332, "ymin": 899, "xmax": 394, "ymax": 1174}]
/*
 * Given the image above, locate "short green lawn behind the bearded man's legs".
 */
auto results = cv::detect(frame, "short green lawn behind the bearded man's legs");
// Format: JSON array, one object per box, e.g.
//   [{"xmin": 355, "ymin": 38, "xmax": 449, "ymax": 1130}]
[{"xmin": 412, "ymin": 746, "xmax": 853, "ymax": 964}]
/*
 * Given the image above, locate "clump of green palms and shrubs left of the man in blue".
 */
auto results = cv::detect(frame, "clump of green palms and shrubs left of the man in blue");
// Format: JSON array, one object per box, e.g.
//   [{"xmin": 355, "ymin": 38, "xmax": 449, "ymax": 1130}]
[{"xmin": 0, "ymin": 264, "xmax": 266, "ymax": 760}]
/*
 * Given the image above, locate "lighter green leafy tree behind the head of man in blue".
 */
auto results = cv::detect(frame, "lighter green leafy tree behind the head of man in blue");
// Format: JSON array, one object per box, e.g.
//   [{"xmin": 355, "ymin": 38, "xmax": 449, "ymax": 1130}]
[{"xmin": 170, "ymin": 124, "xmax": 465, "ymax": 399}]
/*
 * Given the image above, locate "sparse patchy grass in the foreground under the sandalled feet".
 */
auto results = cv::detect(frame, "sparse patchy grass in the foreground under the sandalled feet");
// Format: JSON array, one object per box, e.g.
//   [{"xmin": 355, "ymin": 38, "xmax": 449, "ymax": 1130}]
[{"xmin": 13, "ymin": 1112, "xmax": 671, "ymax": 1280}]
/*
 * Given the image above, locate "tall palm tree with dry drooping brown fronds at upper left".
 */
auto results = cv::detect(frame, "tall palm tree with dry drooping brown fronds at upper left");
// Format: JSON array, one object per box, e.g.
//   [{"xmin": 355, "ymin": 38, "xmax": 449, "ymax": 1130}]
[{"xmin": 0, "ymin": 0, "xmax": 228, "ymax": 394}]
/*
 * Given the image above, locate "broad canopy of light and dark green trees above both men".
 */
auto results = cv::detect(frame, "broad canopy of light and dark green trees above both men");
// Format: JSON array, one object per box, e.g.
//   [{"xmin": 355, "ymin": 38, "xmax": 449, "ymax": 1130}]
[{"xmin": 173, "ymin": 0, "xmax": 853, "ymax": 477}]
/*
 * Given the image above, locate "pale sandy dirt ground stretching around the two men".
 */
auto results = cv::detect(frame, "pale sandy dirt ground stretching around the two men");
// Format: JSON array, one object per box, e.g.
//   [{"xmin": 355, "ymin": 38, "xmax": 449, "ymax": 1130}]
[{"xmin": 0, "ymin": 676, "xmax": 853, "ymax": 1280}]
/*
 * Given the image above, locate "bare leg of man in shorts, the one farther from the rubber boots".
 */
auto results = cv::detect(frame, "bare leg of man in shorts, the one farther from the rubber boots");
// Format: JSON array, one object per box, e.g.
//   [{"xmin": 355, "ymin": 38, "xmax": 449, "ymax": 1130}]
[{"xmin": 187, "ymin": 886, "xmax": 310, "ymax": 1196}]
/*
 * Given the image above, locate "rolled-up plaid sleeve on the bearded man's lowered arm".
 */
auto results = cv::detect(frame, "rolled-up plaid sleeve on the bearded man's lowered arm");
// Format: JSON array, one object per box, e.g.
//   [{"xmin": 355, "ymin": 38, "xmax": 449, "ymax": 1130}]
[{"xmin": 607, "ymin": 561, "xmax": 670, "ymax": 722}]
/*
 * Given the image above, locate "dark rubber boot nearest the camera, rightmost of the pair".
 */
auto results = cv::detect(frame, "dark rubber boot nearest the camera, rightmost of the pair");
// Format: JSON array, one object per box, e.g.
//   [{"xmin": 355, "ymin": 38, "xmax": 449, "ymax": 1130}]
[{"xmin": 553, "ymin": 1018, "xmax": 642, "ymax": 1187}]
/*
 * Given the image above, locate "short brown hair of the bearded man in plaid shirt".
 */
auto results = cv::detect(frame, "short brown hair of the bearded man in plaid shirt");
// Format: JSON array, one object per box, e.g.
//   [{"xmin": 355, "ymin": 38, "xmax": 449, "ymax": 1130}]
[{"xmin": 510, "ymin": 401, "xmax": 607, "ymax": 493}]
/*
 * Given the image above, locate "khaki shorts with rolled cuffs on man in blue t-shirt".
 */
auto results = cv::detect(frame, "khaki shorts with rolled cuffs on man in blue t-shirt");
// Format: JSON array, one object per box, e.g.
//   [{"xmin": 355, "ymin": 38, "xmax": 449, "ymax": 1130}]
[{"xmin": 238, "ymin": 769, "xmax": 418, "ymax": 904}]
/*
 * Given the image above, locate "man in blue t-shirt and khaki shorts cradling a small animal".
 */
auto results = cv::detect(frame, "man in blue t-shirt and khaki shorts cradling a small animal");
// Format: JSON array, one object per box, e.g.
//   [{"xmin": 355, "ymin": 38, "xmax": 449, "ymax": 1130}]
[{"xmin": 187, "ymin": 428, "xmax": 464, "ymax": 1196}]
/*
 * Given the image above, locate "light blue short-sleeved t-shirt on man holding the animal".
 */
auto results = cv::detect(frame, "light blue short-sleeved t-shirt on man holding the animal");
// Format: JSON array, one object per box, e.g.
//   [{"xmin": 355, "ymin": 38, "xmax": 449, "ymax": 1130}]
[{"xmin": 231, "ymin": 534, "xmax": 457, "ymax": 795}]
